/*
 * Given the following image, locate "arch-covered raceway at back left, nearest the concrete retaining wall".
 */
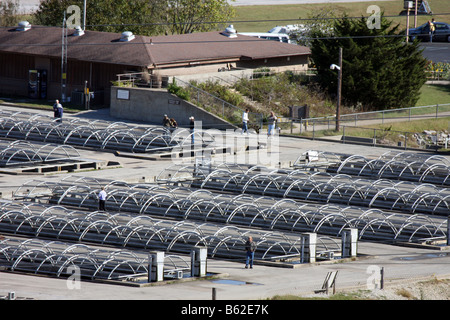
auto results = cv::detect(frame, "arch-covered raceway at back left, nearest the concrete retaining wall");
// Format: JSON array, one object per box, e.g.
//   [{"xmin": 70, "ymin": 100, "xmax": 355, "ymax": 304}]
[{"xmin": 0, "ymin": 111, "xmax": 214, "ymax": 153}]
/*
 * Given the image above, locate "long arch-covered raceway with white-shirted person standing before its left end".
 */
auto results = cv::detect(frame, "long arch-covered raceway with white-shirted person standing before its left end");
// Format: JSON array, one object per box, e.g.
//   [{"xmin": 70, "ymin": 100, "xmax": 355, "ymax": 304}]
[{"xmin": 15, "ymin": 177, "xmax": 446, "ymax": 242}]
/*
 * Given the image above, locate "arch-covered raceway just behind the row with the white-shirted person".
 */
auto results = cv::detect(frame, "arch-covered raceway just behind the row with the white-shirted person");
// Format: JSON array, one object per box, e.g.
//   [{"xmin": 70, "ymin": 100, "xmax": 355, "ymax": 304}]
[{"xmin": 167, "ymin": 165, "xmax": 450, "ymax": 216}]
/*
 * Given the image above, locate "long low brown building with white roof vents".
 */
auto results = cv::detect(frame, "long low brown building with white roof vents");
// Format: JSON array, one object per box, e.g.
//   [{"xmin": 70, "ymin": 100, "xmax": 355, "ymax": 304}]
[{"xmin": 0, "ymin": 21, "xmax": 310, "ymax": 105}]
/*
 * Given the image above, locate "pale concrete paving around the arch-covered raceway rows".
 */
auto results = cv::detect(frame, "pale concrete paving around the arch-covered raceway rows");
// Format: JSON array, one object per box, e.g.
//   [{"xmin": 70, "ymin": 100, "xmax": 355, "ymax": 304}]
[{"xmin": 0, "ymin": 106, "xmax": 450, "ymax": 301}]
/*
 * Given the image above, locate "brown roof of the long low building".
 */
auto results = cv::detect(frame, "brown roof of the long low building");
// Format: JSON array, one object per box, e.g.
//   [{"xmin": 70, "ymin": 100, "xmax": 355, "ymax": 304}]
[{"xmin": 0, "ymin": 26, "xmax": 310, "ymax": 67}]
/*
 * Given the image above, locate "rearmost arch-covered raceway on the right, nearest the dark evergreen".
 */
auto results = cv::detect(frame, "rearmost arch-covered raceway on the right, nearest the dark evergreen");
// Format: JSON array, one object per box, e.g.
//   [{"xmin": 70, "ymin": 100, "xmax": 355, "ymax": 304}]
[{"xmin": 293, "ymin": 150, "xmax": 450, "ymax": 187}]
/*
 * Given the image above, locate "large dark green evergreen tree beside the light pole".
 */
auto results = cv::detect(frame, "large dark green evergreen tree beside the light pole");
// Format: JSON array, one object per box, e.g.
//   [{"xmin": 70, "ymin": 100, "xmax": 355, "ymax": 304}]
[{"xmin": 311, "ymin": 16, "xmax": 426, "ymax": 110}]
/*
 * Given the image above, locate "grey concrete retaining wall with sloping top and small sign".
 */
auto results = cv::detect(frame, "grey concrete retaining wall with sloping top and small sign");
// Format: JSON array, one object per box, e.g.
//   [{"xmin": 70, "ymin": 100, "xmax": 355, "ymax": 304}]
[{"xmin": 110, "ymin": 87, "xmax": 236, "ymax": 129}]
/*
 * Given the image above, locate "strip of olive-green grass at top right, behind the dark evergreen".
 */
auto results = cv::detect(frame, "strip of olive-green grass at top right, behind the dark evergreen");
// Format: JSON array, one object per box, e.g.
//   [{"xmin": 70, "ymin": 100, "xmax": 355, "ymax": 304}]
[{"xmin": 233, "ymin": 0, "xmax": 450, "ymax": 32}]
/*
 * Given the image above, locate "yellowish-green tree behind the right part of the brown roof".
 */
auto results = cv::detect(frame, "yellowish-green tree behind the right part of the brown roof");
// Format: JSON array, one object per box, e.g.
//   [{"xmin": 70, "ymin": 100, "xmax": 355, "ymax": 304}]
[{"xmin": 166, "ymin": 0, "xmax": 235, "ymax": 34}]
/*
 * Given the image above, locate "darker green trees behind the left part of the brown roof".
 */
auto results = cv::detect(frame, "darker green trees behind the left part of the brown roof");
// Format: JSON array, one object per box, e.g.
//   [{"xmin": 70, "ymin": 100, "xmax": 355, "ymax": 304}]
[{"xmin": 34, "ymin": 0, "xmax": 165, "ymax": 35}]
